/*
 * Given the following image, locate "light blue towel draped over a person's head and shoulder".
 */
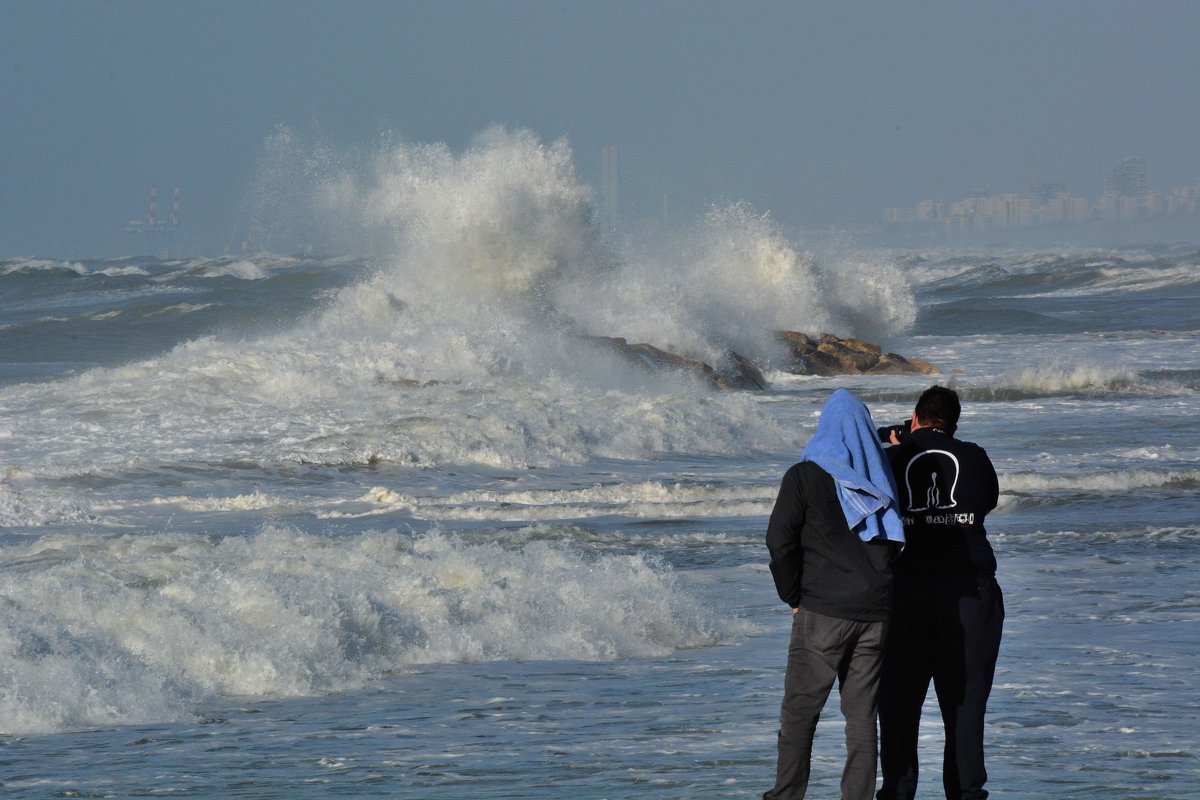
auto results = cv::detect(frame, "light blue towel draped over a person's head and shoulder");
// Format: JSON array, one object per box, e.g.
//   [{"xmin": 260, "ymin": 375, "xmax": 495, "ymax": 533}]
[{"xmin": 800, "ymin": 389, "xmax": 904, "ymax": 545}]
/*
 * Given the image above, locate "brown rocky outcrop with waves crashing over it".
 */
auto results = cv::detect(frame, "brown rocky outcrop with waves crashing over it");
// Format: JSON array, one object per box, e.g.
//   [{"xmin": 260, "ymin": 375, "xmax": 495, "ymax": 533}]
[{"xmin": 584, "ymin": 331, "xmax": 937, "ymax": 389}]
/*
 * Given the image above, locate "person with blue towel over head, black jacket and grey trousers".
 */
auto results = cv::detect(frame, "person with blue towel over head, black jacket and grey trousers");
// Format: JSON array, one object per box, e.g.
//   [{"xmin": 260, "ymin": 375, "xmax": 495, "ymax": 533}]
[{"xmin": 763, "ymin": 389, "xmax": 904, "ymax": 800}]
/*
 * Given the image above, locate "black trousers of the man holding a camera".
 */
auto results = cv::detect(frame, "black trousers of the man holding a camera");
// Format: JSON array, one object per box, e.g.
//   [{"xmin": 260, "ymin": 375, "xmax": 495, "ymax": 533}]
[{"xmin": 877, "ymin": 575, "xmax": 1004, "ymax": 800}]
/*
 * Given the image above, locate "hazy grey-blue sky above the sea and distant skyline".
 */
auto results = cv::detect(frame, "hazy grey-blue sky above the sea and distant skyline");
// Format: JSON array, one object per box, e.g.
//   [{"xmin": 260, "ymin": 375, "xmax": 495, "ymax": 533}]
[{"xmin": 0, "ymin": 0, "xmax": 1200, "ymax": 259}]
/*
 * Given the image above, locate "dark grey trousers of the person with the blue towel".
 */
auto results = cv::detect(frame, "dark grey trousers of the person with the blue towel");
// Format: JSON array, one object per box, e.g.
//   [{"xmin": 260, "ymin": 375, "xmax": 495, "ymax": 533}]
[{"xmin": 762, "ymin": 608, "xmax": 887, "ymax": 800}]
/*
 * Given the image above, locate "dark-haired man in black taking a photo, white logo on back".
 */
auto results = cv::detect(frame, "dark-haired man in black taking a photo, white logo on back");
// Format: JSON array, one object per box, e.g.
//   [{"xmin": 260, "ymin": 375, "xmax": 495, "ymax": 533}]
[{"xmin": 877, "ymin": 386, "xmax": 1004, "ymax": 800}]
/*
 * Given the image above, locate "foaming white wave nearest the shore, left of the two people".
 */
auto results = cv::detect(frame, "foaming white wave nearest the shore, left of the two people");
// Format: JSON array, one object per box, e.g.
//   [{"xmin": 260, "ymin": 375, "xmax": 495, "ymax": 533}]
[{"xmin": 0, "ymin": 528, "xmax": 745, "ymax": 734}]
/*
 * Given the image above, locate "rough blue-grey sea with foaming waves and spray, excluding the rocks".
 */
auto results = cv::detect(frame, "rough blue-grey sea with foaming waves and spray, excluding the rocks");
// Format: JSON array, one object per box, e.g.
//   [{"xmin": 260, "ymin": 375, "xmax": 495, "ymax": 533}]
[{"xmin": 0, "ymin": 132, "xmax": 1200, "ymax": 800}]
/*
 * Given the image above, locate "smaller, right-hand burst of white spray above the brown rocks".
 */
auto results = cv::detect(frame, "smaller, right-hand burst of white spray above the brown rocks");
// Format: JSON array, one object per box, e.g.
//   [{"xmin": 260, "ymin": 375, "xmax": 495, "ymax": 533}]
[{"xmin": 554, "ymin": 205, "xmax": 916, "ymax": 367}]
